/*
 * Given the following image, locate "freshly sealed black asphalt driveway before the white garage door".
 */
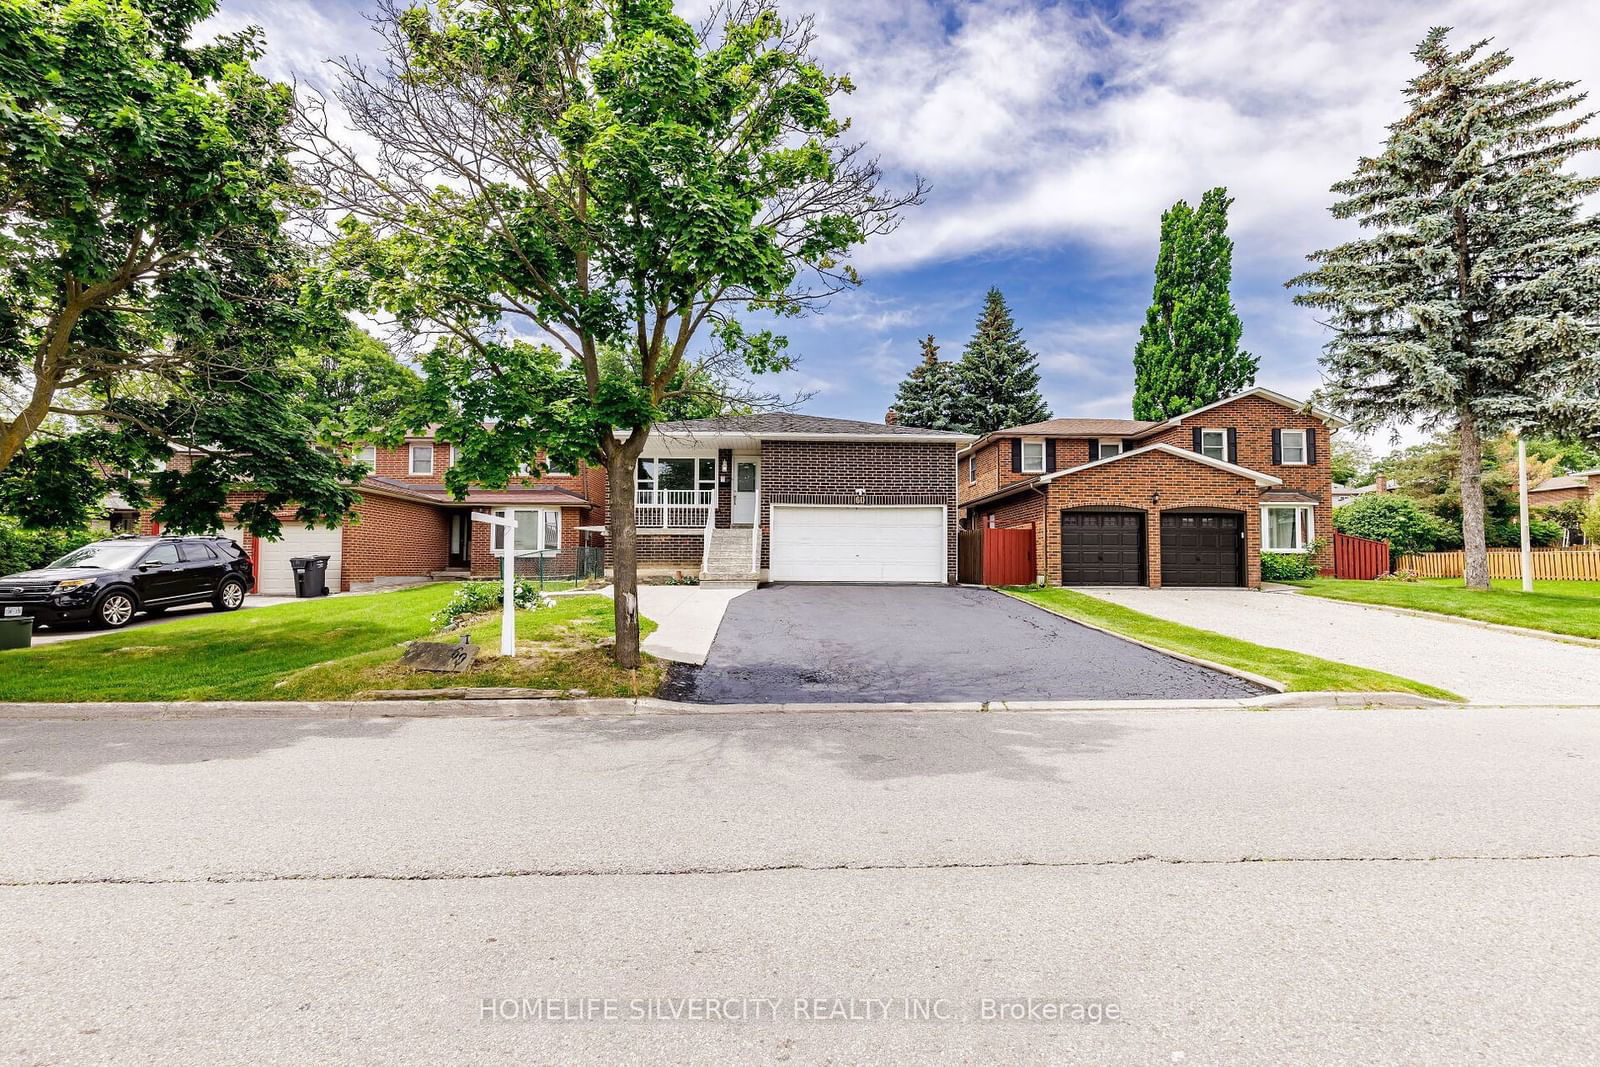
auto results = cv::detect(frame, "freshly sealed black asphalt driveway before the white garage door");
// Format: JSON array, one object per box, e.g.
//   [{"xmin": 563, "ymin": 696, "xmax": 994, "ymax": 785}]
[{"xmin": 670, "ymin": 585, "xmax": 1261, "ymax": 704}]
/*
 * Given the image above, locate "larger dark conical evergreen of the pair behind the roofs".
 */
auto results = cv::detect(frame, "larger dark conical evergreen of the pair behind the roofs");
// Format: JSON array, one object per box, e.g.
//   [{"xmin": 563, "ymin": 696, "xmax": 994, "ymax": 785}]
[{"xmin": 954, "ymin": 290, "xmax": 1050, "ymax": 434}]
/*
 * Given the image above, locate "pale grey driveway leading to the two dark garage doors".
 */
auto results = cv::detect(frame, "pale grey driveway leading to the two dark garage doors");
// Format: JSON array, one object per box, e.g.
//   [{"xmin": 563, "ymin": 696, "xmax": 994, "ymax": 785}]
[{"xmin": 1078, "ymin": 589, "xmax": 1600, "ymax": 704}]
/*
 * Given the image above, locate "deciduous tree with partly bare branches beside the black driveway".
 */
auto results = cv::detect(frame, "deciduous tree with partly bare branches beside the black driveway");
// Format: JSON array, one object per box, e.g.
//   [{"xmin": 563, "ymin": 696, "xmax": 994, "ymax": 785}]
[{"xmin": 301, "ymin": 0, "xmax": 920, "ymax": 667}]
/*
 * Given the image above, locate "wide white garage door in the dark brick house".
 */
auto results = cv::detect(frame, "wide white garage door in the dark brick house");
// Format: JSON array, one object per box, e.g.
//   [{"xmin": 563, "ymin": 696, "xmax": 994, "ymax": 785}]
[{"xmin": 770, "ymin": 504, "xmax": 949, "ymax": 584}]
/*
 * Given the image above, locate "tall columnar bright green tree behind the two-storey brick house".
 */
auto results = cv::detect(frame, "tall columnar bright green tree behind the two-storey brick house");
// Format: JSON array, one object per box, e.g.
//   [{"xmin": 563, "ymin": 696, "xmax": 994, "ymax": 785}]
[{"xmin": 1133, "ymin": 187, "xmax": 1259, "ymax": 419}]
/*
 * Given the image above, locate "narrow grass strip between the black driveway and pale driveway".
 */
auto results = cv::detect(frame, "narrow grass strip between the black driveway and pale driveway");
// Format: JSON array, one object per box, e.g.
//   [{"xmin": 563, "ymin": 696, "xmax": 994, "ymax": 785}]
[{"xmin": 1000, "ymin": 585, "xmax": 1461, "ymax": 701}]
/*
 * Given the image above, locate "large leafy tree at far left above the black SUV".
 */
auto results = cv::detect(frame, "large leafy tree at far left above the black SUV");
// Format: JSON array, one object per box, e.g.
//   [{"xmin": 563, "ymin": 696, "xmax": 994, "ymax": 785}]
[{"xmin": 0, "ymin": 0, "xmax": 354, "ymax": 534}]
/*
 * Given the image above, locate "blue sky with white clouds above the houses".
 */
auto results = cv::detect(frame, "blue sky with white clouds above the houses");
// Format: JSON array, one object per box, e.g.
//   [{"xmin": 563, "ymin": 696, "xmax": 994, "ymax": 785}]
[{"xmin": 214, "ymin": 0, "xmax": 1600, "ymax": 438}]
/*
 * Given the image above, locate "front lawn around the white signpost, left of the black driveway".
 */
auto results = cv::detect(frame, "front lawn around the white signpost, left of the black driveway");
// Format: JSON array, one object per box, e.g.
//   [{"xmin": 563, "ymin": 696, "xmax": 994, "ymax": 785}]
[{"xmin": 0, "ymin": 582, "xmax": 661, "ymax": 702}]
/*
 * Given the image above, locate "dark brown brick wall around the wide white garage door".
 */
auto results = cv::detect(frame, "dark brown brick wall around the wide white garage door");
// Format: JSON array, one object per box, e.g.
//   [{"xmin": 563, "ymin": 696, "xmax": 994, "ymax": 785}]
[{"xmin": 760, "ymin": 440, "xmax": 958, "ymax": 582}]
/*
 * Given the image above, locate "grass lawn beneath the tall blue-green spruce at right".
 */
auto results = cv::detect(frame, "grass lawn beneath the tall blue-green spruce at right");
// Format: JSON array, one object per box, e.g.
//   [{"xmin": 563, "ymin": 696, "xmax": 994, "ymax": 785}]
[{"xmin": 1294, "ymin": 577, "xmax": 1600, "ymax": 637}]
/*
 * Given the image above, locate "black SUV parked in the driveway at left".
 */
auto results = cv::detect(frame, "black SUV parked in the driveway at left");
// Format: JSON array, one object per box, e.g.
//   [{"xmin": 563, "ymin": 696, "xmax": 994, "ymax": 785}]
[{"xmin": 0, "ymin": 536, "xmax": 254, "ymax": 629}]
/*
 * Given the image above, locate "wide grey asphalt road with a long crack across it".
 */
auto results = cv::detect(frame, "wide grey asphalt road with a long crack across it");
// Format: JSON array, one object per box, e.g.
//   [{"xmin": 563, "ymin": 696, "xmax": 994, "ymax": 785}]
[{"xmin": 0, "ymin": 709, "xmax": 1600, "ymax": 1064}]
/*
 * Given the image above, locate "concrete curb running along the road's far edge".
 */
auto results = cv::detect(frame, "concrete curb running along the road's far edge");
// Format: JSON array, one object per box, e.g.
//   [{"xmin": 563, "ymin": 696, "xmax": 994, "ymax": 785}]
[{"xmin": 0, "ymin": 693, "xmax": 1458, "ymax": 721}]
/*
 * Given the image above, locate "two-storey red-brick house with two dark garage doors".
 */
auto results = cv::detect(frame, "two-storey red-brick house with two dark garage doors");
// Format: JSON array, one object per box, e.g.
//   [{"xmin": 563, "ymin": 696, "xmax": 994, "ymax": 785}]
[{"xmin": 958, "ymin": 387, "xmax": 1344, "ymax": 589}]
